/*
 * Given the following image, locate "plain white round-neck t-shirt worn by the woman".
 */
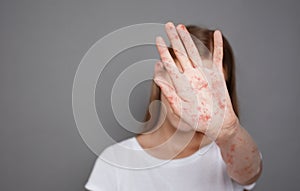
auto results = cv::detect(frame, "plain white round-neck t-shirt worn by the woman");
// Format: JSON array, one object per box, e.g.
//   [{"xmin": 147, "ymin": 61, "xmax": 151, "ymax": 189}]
[{"xmin": 85, "ymin": 137, "xmax": 255, "ymax": 191}]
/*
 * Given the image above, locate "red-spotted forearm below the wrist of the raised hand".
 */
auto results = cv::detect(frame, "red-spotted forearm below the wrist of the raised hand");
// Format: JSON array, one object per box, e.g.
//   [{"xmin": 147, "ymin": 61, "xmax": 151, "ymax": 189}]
[{"xmin": 216, "ymin": 121, "xmax": 262, "ymax": 185}]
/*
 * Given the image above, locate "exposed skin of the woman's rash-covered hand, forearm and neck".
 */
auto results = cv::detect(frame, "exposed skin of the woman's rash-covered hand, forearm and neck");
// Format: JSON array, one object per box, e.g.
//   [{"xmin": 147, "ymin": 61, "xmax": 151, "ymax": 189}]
[{"xmin": 137, "ymin": 22, "xmax": 262, "ymax": 185}]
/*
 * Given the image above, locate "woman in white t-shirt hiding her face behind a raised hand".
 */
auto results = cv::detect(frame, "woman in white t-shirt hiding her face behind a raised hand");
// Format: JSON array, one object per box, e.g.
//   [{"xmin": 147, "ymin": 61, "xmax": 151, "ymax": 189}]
[{"xmin": 85, "ymin": 22, "xmax": 262, "ymax": 191}]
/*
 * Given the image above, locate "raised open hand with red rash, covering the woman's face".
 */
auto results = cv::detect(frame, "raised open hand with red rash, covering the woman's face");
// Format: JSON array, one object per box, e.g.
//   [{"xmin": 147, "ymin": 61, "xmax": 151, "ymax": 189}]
[{"xmin": 154, "ymin": 22, "xmax": 237, "ymax": 138}]
